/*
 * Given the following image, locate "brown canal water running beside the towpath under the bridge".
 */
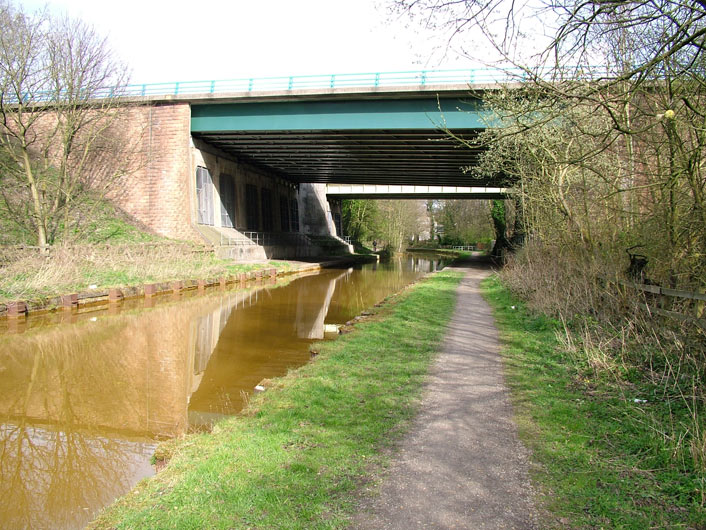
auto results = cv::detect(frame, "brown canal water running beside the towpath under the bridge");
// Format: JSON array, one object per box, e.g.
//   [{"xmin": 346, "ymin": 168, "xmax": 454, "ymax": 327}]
[{"xmin": 0, "ymin": 255, "xmax": 441, "ymax": 528}]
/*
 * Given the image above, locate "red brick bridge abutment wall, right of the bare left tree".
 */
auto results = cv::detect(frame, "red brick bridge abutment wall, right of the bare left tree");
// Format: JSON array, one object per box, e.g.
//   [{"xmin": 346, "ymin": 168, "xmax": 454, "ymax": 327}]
[{"xmin": 113, "ymin": 103, "xmax": 201, "ymax": 241}]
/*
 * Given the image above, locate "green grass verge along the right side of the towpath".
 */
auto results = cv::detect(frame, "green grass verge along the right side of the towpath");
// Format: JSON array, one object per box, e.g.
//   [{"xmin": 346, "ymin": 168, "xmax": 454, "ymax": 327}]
[{"xmin": 483, "ymin": 278, "xmax": 706, "ymax": 529}]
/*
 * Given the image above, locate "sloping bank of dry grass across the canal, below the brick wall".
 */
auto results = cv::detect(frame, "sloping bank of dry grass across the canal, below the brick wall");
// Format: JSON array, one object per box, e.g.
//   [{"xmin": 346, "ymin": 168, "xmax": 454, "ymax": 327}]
[{"xmin": 0, "ymin": 201, "xmax": 291, "ymax": 303}]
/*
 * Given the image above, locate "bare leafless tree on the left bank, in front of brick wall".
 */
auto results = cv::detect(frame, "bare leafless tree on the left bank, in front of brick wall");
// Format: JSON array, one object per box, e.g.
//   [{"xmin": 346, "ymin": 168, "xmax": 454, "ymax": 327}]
[{"xmin": 0, "ymin": 0, "xmax": 134, "ymax": 246}]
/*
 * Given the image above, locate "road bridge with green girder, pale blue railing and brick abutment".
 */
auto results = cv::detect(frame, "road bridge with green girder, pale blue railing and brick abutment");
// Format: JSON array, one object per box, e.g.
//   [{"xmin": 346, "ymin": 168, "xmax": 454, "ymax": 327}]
[{"xmin": 118, "ymin": 70, "xmax": 511, "ymax": 245}]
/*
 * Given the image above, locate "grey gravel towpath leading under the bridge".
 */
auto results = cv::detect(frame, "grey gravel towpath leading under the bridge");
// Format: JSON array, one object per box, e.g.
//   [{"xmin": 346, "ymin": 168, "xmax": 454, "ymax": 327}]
[{"xmin": 351, "ymin": 260, "xmax": 539, "ymax": 530}]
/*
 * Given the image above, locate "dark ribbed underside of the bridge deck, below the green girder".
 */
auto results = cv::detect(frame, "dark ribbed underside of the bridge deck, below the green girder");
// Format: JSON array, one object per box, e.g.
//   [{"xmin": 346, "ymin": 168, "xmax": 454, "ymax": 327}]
[{"xmin": 195, "ymin": 129, "xmax": 485, "ymax": 186}]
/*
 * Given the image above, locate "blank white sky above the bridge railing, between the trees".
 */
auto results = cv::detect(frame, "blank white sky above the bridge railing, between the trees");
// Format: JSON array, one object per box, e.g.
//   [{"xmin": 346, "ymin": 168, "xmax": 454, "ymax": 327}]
[{"xmin": 16, "ymin": 0, "xmax": 473, "ymax": 84}]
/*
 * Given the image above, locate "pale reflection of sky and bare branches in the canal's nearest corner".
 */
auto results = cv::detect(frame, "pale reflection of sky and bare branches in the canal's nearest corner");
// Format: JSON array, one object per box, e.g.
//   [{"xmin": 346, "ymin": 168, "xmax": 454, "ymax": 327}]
[{"xmin": 0, "ymin": 422, "xmax": 155, "ymax": 528}]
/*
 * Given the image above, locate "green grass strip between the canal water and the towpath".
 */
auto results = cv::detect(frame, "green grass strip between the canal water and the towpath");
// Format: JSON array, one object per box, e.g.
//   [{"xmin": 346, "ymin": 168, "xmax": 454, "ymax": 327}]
[{"xmin": 92, "ymin": 271, "xmax": 461, "ymax": 529}]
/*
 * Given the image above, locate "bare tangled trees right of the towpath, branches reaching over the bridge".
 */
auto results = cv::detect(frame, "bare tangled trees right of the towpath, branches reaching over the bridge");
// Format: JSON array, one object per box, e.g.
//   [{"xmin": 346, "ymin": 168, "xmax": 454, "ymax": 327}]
[{"xmin": 394, "ymin": 0, "xmax": 706, "ymax": 289}]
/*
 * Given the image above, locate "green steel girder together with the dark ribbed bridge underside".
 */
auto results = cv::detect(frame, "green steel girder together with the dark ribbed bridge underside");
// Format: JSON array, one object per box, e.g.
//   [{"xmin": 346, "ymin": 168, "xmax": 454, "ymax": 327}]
[{"xmin": 191, "ymin": 94, "xmax": 498, "ymax": 187}]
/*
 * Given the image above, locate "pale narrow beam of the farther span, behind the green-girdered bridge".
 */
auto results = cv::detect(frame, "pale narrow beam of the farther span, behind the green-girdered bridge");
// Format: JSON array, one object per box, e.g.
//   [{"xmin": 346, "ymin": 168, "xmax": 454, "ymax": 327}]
[{"xmin": 326, "ymin": 184, "xmax": 508, "ymax": 199}]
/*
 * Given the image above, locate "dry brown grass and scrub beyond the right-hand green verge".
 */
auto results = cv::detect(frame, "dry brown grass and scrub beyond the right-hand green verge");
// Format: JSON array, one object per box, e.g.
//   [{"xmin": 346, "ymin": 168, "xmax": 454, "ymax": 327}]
[{"xmin": 501, "ymin": 242, "xmax": 706, "ymax": 476}]
